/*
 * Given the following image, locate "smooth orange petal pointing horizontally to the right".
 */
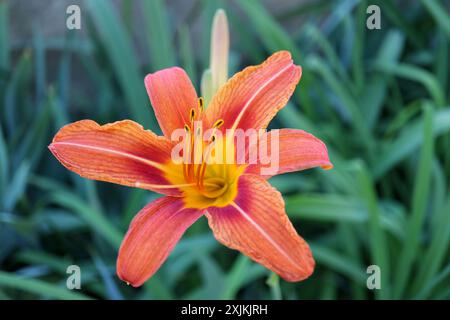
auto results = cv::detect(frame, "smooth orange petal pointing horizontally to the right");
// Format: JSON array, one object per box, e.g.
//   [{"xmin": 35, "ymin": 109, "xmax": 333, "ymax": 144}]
[{"xmin": 245, "ymin": 129, "xmax": 333, "ymax": 178}]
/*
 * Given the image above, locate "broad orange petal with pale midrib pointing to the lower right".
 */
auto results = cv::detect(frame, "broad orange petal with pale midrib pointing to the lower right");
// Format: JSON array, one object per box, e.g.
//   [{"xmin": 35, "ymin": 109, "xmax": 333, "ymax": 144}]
[{"xmin": 206, "ymin": 175, "xmax": 314, "ymax": 281}]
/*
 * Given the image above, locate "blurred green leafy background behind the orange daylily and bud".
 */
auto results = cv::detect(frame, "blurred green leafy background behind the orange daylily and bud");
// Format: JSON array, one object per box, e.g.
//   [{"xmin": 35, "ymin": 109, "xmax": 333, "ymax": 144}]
[{"xmin": 0, "ymin": 0, "xmax": 450, "ymax": 299}]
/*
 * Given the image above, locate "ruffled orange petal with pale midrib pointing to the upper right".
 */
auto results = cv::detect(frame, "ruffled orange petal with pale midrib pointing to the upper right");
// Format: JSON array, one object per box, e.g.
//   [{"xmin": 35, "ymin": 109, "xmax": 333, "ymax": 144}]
[{"xmin": 206, "ymin": 51, "xmax": 302, "ymax": 131}]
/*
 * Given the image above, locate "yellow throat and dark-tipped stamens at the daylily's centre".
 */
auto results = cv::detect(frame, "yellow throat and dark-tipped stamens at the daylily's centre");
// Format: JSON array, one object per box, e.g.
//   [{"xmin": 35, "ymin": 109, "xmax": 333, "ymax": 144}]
[{"xmin": 167, "ymin": 98, "xmax": 243, "ymax": 209}]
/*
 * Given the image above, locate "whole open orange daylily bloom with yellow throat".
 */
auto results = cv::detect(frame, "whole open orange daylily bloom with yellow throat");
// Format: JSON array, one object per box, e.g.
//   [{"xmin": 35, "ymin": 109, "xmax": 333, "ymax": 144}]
[{"xmin": 49, "ymin": 51, "xmax": 332, "ymax": 287}]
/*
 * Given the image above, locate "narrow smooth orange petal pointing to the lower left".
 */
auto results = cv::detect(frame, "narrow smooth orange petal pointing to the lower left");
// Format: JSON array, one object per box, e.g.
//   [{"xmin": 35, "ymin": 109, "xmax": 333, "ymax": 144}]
[{"xmin": 117, "ymin": 197, "xmax": 203, "ymax": 287}]
